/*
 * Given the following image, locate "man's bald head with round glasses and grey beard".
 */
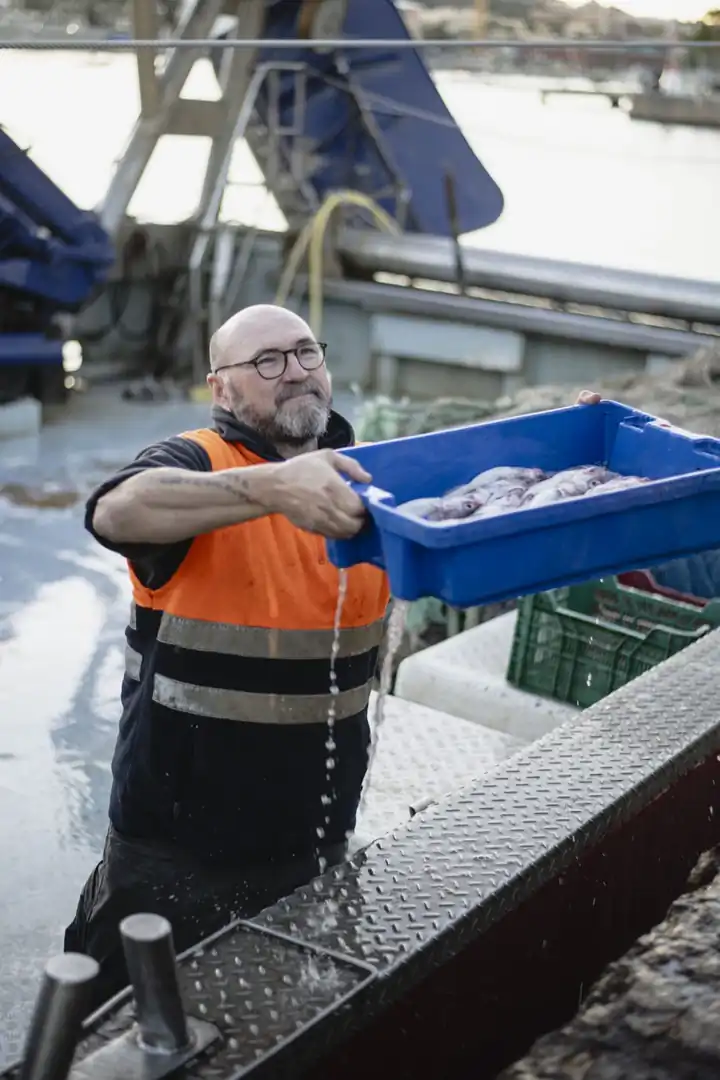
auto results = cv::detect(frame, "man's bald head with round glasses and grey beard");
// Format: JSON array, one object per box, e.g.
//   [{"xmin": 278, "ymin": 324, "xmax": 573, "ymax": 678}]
[{"xmin": 207, "ymin": 303, "xmax": 330, "ymax": 453}]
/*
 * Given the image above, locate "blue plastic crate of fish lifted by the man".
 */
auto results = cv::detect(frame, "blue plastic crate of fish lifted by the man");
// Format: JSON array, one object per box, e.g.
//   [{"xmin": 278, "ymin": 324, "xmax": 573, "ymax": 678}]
[{"xmin": 327, "ymin": 402, "xmax": 720, "ymax": 607}]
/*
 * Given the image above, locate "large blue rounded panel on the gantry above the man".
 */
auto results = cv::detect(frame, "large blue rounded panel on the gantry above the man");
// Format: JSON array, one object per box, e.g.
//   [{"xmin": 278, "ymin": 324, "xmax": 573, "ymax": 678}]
[{"xmin": 218, "ymin": 0, "xmax": 503, "ymax": 237}]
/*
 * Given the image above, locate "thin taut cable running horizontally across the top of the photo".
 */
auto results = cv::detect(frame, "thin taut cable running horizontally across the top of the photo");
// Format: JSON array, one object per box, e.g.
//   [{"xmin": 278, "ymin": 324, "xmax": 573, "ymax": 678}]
[{"xmin": 0, "ymin": 38, "xmax": 720, "ymax": 53}]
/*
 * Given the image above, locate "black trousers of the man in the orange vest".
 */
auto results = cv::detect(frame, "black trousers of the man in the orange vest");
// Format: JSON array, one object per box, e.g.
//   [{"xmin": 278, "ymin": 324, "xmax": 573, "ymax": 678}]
[{"xmin": 65, "ymin": 827, "xmax": 347, "ymax": 1011}]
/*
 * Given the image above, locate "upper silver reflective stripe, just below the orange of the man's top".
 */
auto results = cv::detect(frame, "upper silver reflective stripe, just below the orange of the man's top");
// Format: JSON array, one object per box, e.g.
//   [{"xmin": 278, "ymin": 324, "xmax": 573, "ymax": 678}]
[{"xmin": 158, "ymin": 612, "xmax": 384, "ymax": 660}]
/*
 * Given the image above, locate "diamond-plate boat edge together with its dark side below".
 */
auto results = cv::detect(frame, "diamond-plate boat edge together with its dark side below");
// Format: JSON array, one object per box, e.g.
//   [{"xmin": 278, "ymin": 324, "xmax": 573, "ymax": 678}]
[{"xmin": 1, "ymin": 632, "xmax": 720, "ymax": 1080}]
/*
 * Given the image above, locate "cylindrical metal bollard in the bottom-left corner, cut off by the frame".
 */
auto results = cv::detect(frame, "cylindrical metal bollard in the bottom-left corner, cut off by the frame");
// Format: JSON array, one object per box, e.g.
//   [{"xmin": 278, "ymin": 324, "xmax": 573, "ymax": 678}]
[{"xmin": 21, "ymin": 953, "xmax": 100, "ymax": 1080}]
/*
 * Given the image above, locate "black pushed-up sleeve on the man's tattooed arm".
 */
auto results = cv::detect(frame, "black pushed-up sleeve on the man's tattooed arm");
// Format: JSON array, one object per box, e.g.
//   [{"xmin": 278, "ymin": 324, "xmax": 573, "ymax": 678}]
[{"xmin": 85, "ymin": 435, "xmax": 213, "ymax": 589}]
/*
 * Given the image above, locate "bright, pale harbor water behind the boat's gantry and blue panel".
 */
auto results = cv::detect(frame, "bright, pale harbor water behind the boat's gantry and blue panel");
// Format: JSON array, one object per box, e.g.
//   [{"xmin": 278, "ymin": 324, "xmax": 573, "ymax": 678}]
[{"xmin": 0, "ymin": 50, "xmax": 720, "ymax": 280}]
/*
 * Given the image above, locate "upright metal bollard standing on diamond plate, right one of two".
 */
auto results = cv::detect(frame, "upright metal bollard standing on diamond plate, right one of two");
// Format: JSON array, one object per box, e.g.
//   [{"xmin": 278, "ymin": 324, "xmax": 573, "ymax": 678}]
[{"xmin": 120, "ymin": 915, "xmax": 191, "ymax": 1054}]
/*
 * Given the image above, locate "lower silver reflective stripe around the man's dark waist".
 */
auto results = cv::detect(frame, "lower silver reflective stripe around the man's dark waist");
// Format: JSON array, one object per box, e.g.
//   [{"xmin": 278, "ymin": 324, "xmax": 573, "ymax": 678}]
[{"xmin": 152, "ymin": 675, "xmax": 370, "ymax": 724}]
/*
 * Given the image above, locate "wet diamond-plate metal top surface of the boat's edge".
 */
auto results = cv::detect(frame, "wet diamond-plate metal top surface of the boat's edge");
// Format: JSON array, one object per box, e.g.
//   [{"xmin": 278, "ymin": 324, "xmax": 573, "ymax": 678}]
[{"xmin": 4, "ymin": 632, "xmax": 720, "ymax": 1080}]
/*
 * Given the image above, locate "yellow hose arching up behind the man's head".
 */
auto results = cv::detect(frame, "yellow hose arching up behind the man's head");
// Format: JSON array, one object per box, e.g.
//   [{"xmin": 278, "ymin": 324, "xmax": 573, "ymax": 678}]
[{"xmin": 275, "ymin": 191, "xmax": 400, "ymax": 337}]
